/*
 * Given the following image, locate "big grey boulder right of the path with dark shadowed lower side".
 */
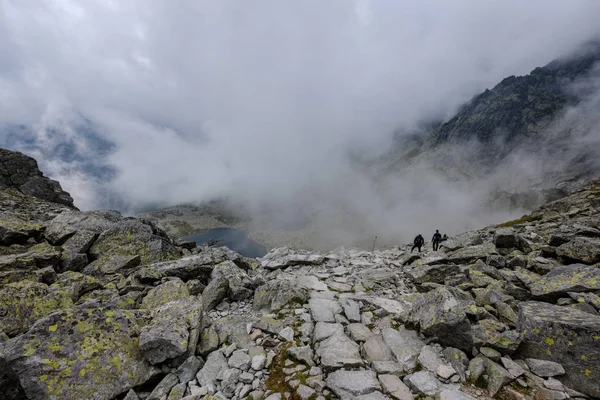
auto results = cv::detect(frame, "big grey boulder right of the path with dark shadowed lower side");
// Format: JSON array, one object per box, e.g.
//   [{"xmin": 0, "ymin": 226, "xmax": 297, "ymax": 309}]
[{"xmin": 408, "ymin": 287, "xmax": 475, "ymax": 353}]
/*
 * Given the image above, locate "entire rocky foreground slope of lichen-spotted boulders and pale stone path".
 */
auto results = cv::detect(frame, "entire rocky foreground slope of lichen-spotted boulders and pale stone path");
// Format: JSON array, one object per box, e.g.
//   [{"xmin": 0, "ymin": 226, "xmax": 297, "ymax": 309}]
[{"xmin": 0, "ymin": 151, "xmax": 600, "ymax": 400}]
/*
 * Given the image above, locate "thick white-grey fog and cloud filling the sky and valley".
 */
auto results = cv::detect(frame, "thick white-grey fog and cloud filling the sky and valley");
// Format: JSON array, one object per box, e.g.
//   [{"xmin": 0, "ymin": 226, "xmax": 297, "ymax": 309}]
[{"xmin": 0, "ymin": 0, "xmax": 600, "ymax": 250}]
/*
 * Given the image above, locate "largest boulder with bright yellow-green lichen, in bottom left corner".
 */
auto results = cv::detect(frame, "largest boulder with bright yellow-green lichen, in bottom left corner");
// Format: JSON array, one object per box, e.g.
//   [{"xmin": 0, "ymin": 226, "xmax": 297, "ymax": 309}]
[{"xmin": 2, "ymin": 303, "xmax": 157, "ymax": 400}]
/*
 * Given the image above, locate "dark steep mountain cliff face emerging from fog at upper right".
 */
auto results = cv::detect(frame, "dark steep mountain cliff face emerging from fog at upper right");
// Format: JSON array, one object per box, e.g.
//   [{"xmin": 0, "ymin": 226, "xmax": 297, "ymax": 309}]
[{"xmin": 430, "ymin": 46, "xmax": 600, "ymax": 145}]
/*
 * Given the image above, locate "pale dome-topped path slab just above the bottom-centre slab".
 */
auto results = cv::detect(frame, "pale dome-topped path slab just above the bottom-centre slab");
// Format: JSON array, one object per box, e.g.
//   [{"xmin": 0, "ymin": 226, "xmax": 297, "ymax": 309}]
[{"xmin": 317, "ymin": 333, "xmax": 363, "ymax": 370}]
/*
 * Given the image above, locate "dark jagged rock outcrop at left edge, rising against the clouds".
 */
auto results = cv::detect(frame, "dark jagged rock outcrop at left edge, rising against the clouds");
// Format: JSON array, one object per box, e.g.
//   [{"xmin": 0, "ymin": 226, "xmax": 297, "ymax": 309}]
[{"xmin": 0, "ymin": 149, "xmax": 75, "ymax": 208}]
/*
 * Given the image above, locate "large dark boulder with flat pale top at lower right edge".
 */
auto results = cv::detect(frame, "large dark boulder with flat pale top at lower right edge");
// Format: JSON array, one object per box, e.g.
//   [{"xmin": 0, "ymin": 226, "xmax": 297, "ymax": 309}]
[{"xmin": 517, "ymin": 301, "xmax": 600, "ymax": 397}]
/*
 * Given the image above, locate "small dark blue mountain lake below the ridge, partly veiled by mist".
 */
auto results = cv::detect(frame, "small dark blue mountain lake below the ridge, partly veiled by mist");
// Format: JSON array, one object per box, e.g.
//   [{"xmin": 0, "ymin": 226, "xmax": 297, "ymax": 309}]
[{"xmin": 184, "ymin": 228, "xmax": 267, "ymax": 258}]
